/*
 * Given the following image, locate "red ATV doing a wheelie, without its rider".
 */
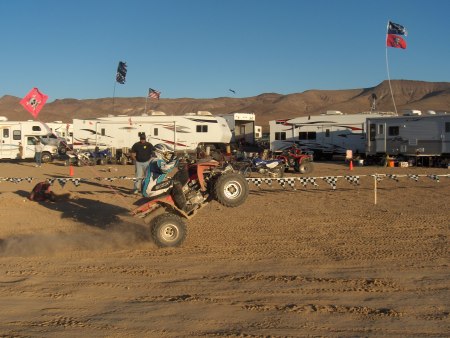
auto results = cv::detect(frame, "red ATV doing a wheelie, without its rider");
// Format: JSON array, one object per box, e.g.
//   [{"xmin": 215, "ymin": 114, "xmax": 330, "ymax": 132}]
[{"xmin": 131, "ymin": 160, "xmax": 249, "ymax": 247}]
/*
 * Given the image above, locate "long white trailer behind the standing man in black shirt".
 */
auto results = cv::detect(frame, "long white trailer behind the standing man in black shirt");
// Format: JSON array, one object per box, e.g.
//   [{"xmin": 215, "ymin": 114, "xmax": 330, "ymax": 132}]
[{"xmin": 73, "ymin": 112, "xmax": 231, "ymax": 156}]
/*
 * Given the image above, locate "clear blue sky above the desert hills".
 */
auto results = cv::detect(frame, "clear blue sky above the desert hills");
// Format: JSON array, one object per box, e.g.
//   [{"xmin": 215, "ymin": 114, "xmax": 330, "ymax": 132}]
[{"xmin": 0, "ymin": 0, "xmax": 450, "ymax": 102}]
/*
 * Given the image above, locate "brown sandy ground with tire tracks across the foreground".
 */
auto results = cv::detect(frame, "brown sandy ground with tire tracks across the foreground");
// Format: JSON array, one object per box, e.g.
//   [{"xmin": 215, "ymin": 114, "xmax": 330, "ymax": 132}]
[{"xmin": 0, "ymin": 162, "xmax": 450, "ymax": 337}]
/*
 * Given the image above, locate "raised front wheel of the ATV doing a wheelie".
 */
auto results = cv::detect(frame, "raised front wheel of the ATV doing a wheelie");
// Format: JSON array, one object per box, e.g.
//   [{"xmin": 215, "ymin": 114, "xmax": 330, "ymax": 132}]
[{"xmin": 214, "ymin": 173, "xmax": 249, "ymax": 208}]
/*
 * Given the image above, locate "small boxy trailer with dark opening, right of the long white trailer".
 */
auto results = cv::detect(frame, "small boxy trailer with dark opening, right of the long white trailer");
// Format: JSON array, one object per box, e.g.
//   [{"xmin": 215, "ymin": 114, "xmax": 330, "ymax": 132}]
[{"xmin": 220, "ymin": 113, "xmax": 257, "ymax": 144}]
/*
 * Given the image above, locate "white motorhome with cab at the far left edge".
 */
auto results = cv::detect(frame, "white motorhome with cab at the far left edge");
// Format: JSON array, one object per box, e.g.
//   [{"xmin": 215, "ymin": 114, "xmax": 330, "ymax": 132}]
[{"xmin": 0, "ymin": 118, "xmax": 58, "ymax": 163}]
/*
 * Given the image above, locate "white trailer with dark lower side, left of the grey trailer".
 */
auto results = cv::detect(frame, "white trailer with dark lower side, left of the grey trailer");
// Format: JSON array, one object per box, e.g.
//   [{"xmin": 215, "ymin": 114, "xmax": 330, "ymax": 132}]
[{"xmin": 269, "ymin": 110, "xmax": 395, "ymax": 159}]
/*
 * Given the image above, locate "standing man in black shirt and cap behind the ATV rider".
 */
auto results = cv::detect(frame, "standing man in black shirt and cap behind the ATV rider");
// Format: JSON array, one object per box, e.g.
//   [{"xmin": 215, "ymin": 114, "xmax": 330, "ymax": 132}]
[{"xmin": 131, "ymin": 133, "xmax": 154, "ymax": 195}]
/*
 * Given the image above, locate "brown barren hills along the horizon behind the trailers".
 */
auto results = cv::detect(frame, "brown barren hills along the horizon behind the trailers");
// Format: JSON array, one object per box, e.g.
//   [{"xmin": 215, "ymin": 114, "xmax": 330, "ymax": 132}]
[{"xmin": 0, "ymin": 80, "xmax": 450, "ymax": 130}]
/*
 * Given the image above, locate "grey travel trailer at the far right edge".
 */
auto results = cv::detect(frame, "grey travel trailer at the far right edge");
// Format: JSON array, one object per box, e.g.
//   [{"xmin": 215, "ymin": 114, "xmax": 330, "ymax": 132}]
[{"xmin": 366, "ymin": 113, "xmax": 450, "ymax": 165}]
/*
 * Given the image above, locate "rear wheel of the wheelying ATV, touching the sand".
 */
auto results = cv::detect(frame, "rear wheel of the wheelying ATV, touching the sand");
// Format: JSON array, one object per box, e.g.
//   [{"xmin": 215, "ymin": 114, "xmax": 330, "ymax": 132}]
[{"xmin": 150, "ymin": 212, "xmax": 187, "ymax": 247}]
